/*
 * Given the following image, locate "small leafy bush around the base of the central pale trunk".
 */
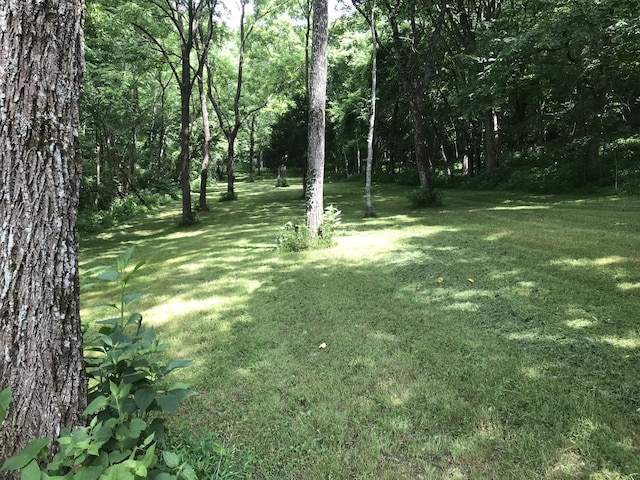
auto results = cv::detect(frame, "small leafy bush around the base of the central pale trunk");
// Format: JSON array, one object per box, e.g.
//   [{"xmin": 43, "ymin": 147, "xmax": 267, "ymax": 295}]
[{"xmin": 276, "ymin": 205, "xmax": 342, "ymax": 252}]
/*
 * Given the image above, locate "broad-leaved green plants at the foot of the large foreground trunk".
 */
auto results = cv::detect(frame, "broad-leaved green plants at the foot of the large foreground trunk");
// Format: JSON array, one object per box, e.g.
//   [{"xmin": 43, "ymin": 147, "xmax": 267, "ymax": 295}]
[{"xmin": 0, "ymin": 247, "xmax": 250, "ymax": 480}]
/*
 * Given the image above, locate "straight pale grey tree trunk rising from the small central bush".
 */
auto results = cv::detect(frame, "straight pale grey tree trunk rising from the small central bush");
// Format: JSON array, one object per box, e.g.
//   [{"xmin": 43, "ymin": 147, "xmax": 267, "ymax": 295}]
[{"xmin": 305, "ymin": 0, "xmax": 329, "ymax": 235}]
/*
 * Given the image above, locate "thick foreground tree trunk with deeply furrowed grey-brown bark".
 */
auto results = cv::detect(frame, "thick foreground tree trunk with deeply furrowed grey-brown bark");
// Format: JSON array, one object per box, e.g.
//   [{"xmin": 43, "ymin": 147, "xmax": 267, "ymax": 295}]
[{"xmin": 0, "ymin": 0, "xmax": 86, "ymax": 466}]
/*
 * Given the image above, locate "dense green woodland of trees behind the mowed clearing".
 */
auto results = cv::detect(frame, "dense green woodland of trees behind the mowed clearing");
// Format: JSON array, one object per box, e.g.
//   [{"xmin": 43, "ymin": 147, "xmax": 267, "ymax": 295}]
[{"xmin": 81, "ymin": 0, "xmax": 640, "ymax": 229}]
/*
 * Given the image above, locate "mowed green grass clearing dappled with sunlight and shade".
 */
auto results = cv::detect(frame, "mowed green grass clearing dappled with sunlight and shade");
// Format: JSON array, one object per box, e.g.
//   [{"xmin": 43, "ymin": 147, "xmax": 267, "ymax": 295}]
[{"xmin": 81, "ymin": 181, "xmax": 640, "ymax": 480}]
